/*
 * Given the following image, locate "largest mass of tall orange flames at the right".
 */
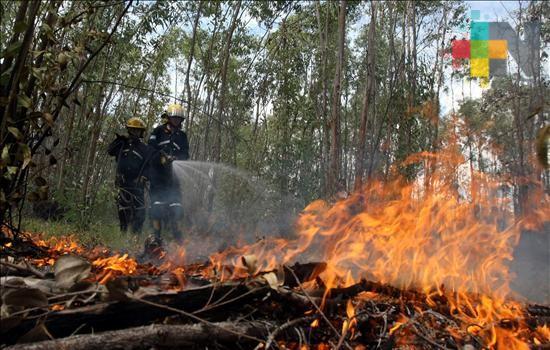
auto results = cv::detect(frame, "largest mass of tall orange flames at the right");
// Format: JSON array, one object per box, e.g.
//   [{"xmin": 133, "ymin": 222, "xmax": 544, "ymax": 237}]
[{"xmin": 211, "ymin": 147, "xmax": 550, "ymax": 349}]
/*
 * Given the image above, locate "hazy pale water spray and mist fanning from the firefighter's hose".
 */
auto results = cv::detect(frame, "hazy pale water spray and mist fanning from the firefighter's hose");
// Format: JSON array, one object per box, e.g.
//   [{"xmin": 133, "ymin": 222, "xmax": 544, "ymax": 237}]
[{"xmin": 173, "ymin": 161, "xmax": 302, "ymax": 259}]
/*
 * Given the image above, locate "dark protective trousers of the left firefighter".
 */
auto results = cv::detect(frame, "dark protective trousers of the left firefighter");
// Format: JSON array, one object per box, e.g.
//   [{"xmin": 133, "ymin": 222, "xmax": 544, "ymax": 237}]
[{"xmin": 117, "ymin": 187, "xmax": 145, "ymax": 234}]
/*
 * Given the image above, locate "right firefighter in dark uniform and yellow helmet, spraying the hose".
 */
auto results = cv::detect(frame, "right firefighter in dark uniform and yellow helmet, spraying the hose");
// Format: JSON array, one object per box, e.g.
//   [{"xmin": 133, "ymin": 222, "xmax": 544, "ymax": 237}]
[{"xmin": 149, "ymin": 104, "xmax": 189, "ymax": 241}]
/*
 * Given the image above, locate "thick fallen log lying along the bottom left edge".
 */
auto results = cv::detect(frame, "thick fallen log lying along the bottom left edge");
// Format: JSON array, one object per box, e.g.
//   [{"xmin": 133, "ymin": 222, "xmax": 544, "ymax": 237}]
[{"xmin": 5, "ymin": 321, "xmax": 273, "ymax": 350}]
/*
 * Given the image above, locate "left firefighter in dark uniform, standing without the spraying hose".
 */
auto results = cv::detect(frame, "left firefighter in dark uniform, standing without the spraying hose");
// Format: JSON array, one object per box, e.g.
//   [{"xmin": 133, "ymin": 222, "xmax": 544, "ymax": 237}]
[{"xmin": 107, "ymin": 118, "xmax": 152, "ymax": 234}]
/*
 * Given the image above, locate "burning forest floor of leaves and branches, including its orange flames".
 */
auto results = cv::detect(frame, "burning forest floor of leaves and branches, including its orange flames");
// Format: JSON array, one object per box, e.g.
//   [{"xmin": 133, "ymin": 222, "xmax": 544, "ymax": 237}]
[{"xmin": 2, "ymin": 147, "xmax": 550, "ymax": 349}]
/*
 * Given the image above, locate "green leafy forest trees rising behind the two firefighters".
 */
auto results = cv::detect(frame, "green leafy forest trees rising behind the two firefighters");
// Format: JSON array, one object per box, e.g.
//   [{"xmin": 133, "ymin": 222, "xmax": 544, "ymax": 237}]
[{"xmin": 0, "ymin": 1, "xmax": 548, "ymax": 237}]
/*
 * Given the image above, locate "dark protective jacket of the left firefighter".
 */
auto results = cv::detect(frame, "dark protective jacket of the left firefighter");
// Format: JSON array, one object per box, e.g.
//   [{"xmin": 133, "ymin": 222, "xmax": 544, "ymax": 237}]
[{"xmin": 107, "ymin": 136, "xmax": 153, "ymax": 187}]
